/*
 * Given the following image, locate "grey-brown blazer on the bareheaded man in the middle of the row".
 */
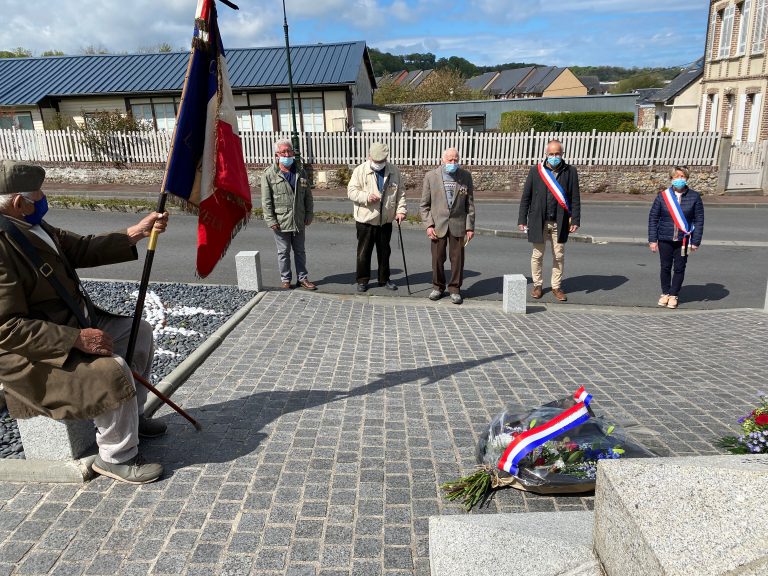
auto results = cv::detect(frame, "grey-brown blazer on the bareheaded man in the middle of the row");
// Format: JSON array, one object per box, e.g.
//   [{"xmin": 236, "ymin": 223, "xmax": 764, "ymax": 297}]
[{"xmin": 419, "ymin": 165, "xmax": 475, "ymax": 238}]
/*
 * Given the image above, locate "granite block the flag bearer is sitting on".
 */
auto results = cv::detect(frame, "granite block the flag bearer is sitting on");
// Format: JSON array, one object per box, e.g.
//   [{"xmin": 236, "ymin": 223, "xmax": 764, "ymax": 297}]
[{"xmin": 16, "ymin": 416, "xmax": 96, "ymax": 461}]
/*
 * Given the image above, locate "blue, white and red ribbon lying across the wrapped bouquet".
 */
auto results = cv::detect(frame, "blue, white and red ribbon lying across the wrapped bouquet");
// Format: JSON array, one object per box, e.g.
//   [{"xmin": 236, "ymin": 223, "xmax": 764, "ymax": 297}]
[{"xmin": 497, "ymin": 386, "xmax": 592, "ymax": 475}]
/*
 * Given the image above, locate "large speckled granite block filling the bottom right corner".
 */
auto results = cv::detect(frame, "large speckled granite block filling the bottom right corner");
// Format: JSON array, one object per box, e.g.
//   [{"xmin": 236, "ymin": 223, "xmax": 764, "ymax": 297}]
[{"xmin": 593, "ymin": 454, "xmax": 768, "ymax": 576}]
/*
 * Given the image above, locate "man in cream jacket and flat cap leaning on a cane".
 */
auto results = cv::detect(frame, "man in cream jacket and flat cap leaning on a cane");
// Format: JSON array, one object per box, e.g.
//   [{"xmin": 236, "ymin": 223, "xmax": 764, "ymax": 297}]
[{"xmin": 347, "ymin": 142, "xmax": 408, "ymax": 293}]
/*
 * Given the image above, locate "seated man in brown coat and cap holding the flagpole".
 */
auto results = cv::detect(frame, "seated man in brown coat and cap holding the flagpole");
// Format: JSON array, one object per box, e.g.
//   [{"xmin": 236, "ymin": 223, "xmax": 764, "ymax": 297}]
[{"xmin": 0, "ymin": 160, "xmax": 168, "ymax": 484}]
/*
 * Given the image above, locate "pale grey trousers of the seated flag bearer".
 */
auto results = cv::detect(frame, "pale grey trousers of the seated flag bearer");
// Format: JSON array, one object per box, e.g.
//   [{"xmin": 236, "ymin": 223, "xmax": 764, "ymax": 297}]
[{"xmin": 93, "ymin": 315, "xmax": 154, "ymax": 464}]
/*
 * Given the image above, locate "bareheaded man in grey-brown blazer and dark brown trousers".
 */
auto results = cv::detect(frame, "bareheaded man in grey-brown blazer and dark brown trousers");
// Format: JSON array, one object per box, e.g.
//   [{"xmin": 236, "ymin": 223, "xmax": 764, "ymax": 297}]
[{"xmin": 420, "ymin": 148, "xmax": 475, "ymax": 304}]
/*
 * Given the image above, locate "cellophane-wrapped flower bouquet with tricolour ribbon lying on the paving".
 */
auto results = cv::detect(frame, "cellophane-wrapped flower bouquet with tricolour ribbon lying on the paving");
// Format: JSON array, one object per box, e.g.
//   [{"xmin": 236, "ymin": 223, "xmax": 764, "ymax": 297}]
[{"xmin": 441, "ymin": 387, "xmax": 653, "ymax": 510}]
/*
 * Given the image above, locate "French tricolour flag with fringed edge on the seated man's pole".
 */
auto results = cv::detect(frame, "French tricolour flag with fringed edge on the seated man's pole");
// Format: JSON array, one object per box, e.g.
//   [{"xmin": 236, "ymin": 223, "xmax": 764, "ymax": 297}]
[{"xmin": 163, "ymin": 0, "xmax": 252, "ymax": 278}]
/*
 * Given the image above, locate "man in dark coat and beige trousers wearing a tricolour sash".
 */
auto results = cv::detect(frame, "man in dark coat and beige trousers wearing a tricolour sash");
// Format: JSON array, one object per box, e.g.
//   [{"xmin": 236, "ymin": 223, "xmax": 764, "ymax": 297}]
[{"xmin": 517, "ymin": 140, "xmax": 581, "ymax": 302}]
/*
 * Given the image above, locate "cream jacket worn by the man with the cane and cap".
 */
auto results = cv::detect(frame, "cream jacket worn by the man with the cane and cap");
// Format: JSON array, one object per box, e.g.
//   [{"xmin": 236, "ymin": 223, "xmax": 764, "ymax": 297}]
[{"xmin": 347, "ymin": 161, "xmax": 408, "ymax": 226}]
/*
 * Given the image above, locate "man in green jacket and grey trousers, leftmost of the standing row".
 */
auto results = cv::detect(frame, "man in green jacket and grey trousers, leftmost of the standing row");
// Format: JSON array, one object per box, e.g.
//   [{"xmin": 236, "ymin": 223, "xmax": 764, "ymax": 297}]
[{"xmin": 261, "ymin": 140, "xmax": 317, "ymax": 290}]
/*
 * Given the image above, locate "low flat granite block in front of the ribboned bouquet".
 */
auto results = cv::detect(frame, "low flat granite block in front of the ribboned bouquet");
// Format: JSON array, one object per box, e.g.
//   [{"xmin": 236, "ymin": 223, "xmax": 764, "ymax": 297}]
[{"xmin": 429, "ymin": 512, "xmax": 602, "ymax": 576}]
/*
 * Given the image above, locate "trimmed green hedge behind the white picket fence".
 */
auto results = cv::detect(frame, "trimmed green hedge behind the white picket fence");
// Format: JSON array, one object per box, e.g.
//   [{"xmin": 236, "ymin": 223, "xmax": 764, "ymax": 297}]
[{"xmin": 499, "ymin": 110, "xmax": 635, "ymax": 132}]
